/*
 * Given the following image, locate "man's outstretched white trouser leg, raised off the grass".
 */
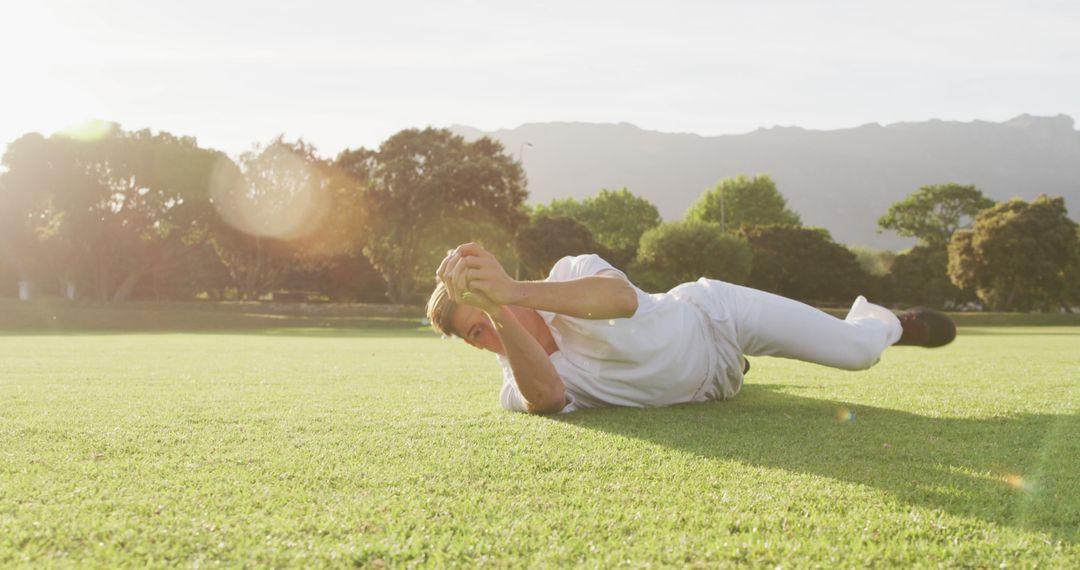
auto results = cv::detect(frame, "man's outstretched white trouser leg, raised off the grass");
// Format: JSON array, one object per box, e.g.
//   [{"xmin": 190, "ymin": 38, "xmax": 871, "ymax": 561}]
[{"xmin": 728, "ymin": 285, "xmax": 902, "ymax": 370}]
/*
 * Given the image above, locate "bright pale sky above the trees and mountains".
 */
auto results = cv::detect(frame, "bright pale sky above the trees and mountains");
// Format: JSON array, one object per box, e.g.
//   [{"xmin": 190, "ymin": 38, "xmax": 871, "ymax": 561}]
[{"xmin": 0, "ymin": 0, "xmax": 1080, "ymax": 155}]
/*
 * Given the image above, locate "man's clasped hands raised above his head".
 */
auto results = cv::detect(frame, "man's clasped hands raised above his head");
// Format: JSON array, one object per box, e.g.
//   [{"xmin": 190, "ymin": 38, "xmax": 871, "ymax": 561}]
[{"xmin": 435, "ymin": 243, "xmax": 517, "ymax": 313}]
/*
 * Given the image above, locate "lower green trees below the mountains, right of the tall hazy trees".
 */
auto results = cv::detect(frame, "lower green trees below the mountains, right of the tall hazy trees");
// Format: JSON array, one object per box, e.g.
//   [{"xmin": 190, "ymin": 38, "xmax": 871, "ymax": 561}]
[{"xmin": 521, "ymin": 176, "xmax": 1080, "ymax": 311}]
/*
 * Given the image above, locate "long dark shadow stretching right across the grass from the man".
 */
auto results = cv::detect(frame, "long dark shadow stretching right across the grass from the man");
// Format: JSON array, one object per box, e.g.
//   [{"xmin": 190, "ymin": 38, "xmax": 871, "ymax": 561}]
[{"xmin": 556, "ymin": 384, "xmax": 1080, "ymax": 543}]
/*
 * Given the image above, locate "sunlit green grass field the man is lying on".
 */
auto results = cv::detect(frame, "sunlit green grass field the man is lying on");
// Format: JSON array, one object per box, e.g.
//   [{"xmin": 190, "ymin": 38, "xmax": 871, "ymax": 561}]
[{"xmin": 0, "ymin": 303, "xmax": 1080, "ymax": 568}]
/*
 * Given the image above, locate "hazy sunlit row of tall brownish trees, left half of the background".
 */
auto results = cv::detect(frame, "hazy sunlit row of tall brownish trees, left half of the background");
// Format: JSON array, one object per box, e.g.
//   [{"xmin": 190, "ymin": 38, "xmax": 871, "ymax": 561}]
[{"xmin": 0, "ymin": 124, "xmax": 527, "ymax": 303}]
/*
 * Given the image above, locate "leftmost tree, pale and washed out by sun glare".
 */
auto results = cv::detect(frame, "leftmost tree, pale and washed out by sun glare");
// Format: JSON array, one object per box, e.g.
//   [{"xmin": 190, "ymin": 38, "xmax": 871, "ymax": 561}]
[{"xmin": 4, "ymin": 123, "xmax": 228, "ymax": 300}]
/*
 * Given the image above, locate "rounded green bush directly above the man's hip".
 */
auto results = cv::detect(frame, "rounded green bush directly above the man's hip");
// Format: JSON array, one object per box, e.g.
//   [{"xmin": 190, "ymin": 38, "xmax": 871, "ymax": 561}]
[{"xmin": 631, "ymin": 221, "xmax": 753, "ymax": 290}]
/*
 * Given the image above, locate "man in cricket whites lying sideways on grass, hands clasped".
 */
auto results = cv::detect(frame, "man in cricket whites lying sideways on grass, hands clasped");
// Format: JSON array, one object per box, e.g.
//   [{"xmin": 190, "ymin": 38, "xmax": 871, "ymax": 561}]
[{"xmin": 428, "ymin": 244, "xmax": 956, "ymax": 413}]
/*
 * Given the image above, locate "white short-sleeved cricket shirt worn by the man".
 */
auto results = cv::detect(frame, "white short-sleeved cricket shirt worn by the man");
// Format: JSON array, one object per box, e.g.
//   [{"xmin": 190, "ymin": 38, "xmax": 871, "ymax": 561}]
[{"xmin": 498, "ymin": 255, "xmax": 742, "ymax": 412}]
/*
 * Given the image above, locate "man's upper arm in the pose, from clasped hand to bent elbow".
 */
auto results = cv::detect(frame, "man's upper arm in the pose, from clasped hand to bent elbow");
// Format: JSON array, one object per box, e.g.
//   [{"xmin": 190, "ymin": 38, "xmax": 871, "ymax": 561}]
[{"xmin": 438, "ymin": 244, "xmax": 637, "ymax": 320}]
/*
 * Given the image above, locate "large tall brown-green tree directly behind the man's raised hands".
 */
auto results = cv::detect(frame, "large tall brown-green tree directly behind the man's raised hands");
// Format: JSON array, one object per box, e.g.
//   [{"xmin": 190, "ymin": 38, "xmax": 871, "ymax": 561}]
[{"xmin": 335, "ymin": 128, "xmax": 527, "ymax": 303}]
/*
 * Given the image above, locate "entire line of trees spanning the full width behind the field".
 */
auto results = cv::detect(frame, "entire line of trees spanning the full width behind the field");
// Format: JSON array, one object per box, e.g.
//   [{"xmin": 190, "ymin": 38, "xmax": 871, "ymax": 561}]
[{"xmin": 0, "ymin": 124, "xmax": 1080, "ymax": 310}]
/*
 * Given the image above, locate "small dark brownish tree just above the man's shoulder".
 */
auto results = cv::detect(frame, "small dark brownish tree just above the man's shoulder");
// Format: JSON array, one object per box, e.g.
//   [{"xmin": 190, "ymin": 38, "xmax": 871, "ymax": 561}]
[{"xmin": 516, "ymin": 214, "xmax": 602, "ymax": 279}]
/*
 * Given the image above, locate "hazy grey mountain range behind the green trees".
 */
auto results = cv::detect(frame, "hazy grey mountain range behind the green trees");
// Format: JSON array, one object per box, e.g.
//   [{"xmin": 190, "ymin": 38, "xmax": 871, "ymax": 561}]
[{"xmin": 450, "ymin": 114, "xmax": 1080, "ymax": 249}]
